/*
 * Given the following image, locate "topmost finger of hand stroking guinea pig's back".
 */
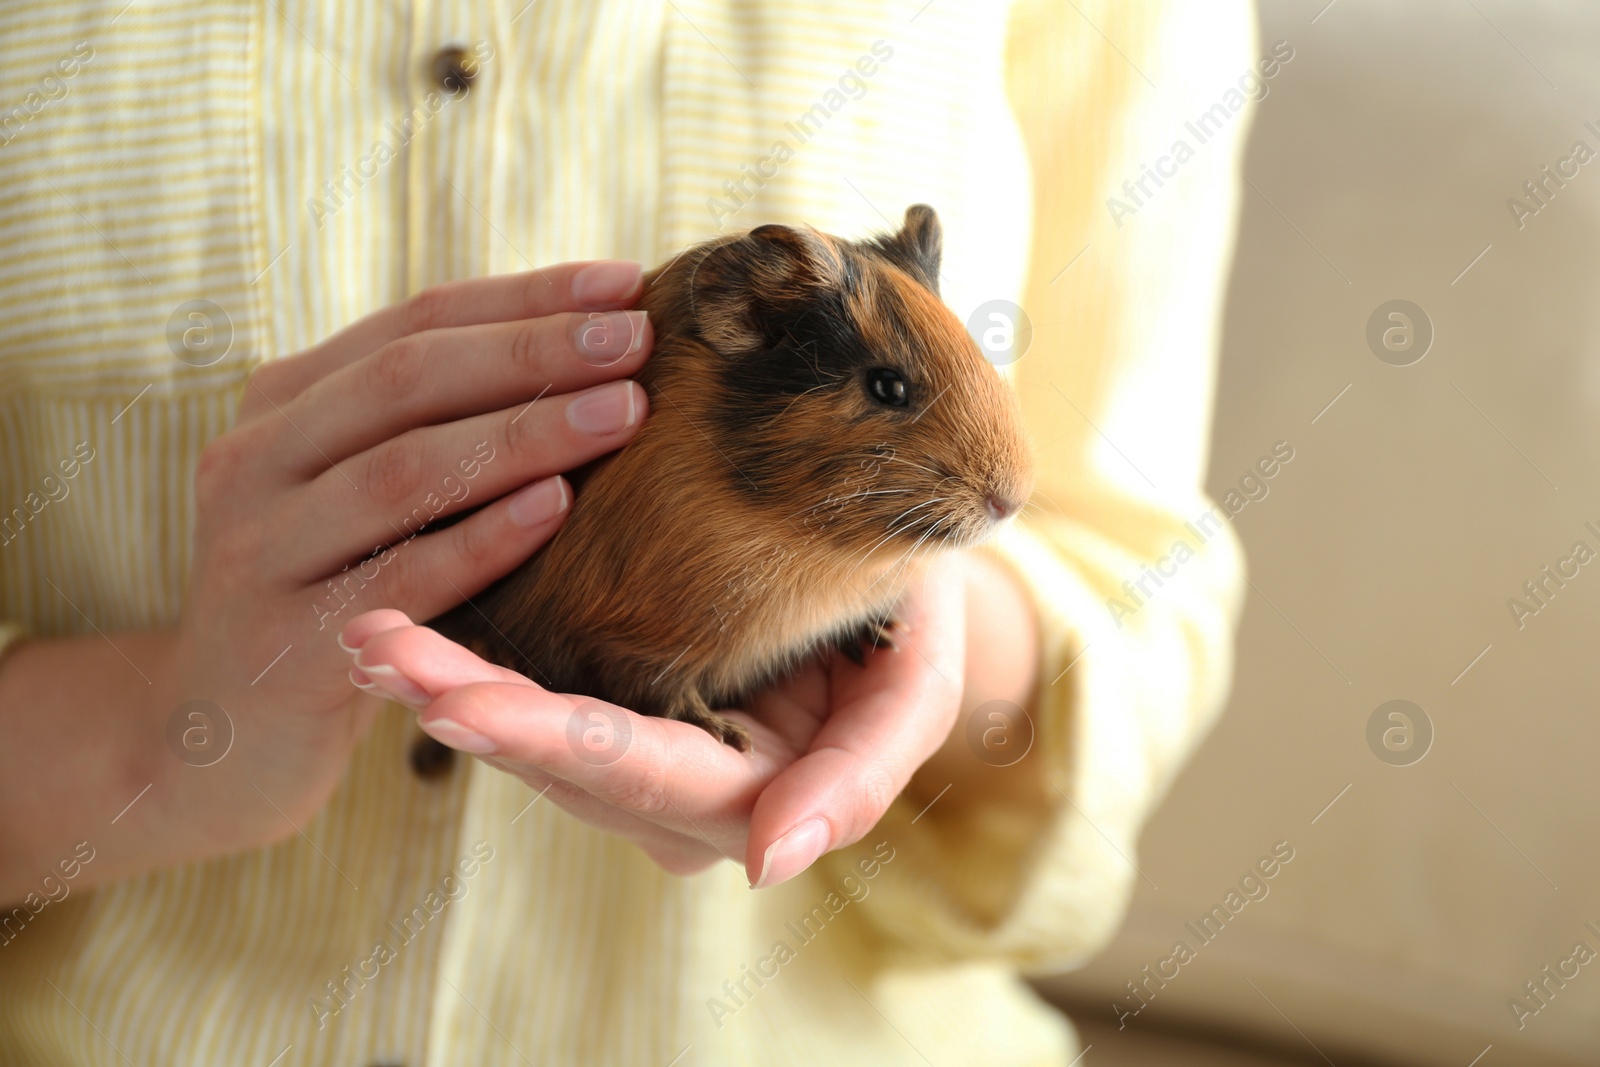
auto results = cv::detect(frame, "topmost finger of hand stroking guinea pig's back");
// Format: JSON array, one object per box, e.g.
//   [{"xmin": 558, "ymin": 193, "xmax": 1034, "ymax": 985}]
[{"xmin": 238, "ymin": 259, "xmax": 643, "ymax": 424}]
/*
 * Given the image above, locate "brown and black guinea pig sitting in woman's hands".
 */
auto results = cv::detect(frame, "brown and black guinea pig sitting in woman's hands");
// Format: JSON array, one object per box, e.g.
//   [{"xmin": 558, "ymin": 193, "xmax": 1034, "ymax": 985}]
[{"xmin": 432, "ymin": 205, "xmax": 1032, "ymax": 750}]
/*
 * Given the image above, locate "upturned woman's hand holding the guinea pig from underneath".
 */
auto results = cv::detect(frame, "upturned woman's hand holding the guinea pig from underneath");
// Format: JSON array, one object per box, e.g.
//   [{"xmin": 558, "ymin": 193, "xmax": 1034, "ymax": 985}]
[{"xmin": 341, "ymin": 557, "xmax": 966, "ymax": 886}]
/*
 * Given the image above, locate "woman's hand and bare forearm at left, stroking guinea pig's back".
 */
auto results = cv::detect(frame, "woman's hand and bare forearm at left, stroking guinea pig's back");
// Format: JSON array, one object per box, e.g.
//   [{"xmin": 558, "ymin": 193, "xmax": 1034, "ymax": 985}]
[{"xmin": 0, "ymin": 262, "xmax": 651, "ymax": 896}]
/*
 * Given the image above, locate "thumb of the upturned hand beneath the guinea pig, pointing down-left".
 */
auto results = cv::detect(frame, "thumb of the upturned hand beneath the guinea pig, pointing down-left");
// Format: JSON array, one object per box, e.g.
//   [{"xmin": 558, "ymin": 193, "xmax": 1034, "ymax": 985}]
[{"xmin": 744, "ymin": 581, "xmax": 965, "ymax": 888}]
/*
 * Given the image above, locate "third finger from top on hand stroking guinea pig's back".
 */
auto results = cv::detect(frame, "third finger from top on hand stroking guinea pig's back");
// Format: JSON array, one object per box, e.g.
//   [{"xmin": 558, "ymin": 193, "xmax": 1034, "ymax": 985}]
[{"xmin": 277, "ymin": 381, "xmax": 648, "ymax": 585}]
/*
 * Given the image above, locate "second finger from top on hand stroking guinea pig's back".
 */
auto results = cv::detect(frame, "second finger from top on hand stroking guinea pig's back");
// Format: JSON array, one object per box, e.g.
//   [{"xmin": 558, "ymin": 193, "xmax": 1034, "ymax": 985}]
[{"xmin": 274, "ymin": 310, "xmax": 651, "ymax": 480}]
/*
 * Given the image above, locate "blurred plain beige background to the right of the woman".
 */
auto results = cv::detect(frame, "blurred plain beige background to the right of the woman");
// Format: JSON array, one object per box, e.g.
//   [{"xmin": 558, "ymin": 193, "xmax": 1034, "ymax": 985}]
[{"xmin": 1042, "ymin": 0, "xmax": 1600, "ymax": 1067}]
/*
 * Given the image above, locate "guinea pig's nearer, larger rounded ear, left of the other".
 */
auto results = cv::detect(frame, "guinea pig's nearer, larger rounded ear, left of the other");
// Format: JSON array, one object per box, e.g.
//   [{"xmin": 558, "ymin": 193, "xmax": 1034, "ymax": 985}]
[{"xmin": 690, "ymin": 224, "xmax": 845, "ymax": 354}]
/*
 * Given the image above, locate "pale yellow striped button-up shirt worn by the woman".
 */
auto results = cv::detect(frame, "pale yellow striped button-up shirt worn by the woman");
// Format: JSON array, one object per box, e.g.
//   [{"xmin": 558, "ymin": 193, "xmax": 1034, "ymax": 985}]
[{"xmin": 0, "ymin": 0, "xmax": 1256, "ymax": 1067}]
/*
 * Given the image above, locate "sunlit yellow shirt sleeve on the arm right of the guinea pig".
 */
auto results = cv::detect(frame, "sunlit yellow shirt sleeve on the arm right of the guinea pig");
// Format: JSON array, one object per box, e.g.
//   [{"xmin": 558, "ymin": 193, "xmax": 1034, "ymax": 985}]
[{"xmin": 838, "ymin": 0, "xmax": 1277, "ymax": 969}]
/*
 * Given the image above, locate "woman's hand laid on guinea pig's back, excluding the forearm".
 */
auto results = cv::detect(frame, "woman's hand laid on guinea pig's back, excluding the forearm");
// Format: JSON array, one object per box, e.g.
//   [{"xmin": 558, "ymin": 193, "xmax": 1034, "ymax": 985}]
[{"xmin": 173, "ymin": 262, "xmax": 650, "ymax": 825}]
